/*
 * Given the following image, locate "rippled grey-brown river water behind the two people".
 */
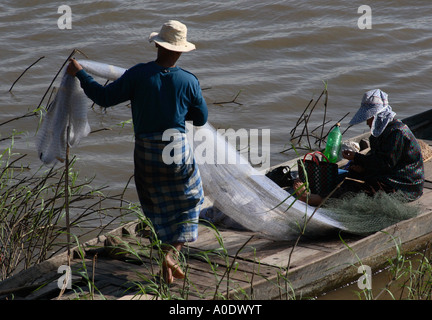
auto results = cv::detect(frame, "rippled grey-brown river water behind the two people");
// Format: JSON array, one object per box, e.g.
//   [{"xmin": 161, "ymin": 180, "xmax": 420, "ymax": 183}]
[{"xmin": 0, "ymin": 0, "xmax": 432, "ymax": 298}]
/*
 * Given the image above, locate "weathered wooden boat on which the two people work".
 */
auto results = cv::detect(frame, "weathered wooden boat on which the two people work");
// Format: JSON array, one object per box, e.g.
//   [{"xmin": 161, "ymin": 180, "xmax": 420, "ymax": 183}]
[{"xmin": 0, "ymin": 110, "xmax": 432, "ymax": 300}]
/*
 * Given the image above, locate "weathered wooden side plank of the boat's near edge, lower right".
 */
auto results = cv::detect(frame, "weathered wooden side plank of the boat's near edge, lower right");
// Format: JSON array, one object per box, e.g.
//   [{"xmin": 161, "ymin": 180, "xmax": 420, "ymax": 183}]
[{"xmin": 233, "ymin": 212, "xmax": 432, "ymax": 299}]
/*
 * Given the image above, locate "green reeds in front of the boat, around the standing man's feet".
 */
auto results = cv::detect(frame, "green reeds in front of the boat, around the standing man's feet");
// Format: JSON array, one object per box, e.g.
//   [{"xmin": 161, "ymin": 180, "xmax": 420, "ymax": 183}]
[{"xmin": 57, "ymin": 216, "xmax": 259, "ymax": 300}]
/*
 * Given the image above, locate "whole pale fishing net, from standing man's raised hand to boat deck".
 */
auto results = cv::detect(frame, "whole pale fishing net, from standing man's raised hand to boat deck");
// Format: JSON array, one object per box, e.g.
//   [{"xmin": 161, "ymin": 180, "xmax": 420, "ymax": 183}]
[{"xmin": 37, "ymin": 60, "xmax": 415, "ymax": 240}]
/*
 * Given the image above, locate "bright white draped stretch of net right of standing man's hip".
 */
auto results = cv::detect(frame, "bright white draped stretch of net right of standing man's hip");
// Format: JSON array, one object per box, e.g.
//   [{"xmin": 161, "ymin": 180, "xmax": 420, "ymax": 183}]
[{"xmin": 194, "ymin": 123, "xmax": 341, "ymax": 240}]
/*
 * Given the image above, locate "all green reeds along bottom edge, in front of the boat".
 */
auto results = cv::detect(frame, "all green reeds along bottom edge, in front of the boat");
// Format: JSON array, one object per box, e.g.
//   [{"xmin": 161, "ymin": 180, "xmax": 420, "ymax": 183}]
[{"xmin": 53, "ymin": 218, "xmax": 432, "ymax": 300}]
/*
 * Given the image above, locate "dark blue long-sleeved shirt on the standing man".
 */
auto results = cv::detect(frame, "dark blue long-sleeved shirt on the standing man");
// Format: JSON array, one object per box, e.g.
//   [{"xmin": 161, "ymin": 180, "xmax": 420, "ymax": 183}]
[{"xmin": 76, "ymin": 62, "xmax": 208, "ymax": 137}]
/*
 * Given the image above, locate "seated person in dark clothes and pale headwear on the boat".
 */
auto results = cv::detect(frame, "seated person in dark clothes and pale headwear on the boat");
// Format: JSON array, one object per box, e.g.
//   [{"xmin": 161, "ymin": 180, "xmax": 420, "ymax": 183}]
[{"xmin": 294, "ymin": 89, "xmax": 424, "ymax": 206}]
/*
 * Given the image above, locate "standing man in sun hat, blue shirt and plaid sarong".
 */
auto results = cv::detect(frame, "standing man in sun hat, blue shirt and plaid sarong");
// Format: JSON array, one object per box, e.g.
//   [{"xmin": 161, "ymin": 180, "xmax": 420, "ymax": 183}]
[{"xmin": 67, "ymin": 20, "xmax": 208, "ymax": 283}]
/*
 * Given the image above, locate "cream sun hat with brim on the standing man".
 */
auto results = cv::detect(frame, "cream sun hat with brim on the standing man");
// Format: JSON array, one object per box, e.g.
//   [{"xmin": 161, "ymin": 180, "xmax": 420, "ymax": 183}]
[{"xmin": 149, "ymin": 20, "xmax": 195, "ymax": 52}]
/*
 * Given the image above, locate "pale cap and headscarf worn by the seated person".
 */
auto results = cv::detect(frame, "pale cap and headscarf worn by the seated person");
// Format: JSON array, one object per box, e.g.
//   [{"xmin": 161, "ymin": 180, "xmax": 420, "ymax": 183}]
[{"xmin": 349, "ymin": 89, "xmax": 396, "ymax": 137}]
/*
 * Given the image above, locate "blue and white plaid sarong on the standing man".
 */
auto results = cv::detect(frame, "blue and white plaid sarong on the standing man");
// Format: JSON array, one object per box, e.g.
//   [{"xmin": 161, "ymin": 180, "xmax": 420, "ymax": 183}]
[{"xmin": 134, "ymin": 132, "xmax": 204, "ymax": 244}]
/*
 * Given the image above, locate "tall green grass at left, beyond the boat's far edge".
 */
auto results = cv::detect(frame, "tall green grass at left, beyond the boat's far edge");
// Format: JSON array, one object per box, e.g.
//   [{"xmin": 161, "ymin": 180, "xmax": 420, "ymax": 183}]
[{"xmin": 0, "ymin": 130, "xmax": 133, "ymax": 280}]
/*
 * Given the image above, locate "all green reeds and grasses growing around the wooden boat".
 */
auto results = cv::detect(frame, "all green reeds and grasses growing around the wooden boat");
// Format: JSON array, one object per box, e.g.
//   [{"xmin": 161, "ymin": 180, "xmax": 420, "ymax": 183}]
[{"xmin": 0, "ymin": 66, "xmax": 432, "ymax": 300}]
